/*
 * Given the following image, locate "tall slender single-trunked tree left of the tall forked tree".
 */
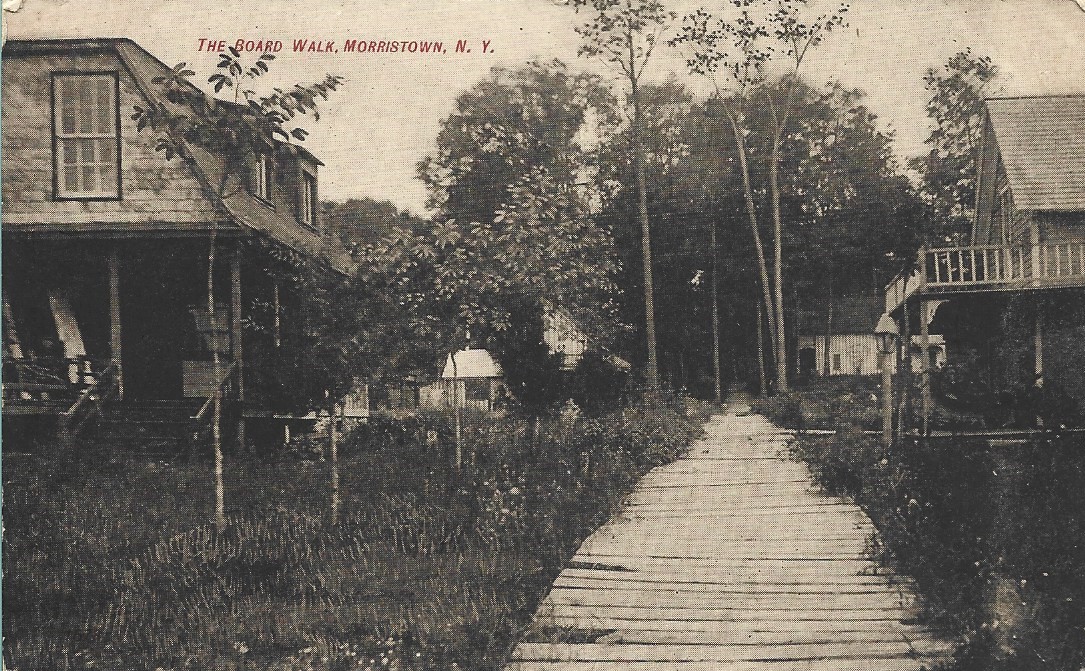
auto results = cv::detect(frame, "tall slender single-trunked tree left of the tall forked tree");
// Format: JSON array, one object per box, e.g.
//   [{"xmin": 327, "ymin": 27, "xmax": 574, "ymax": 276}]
[{"xmin": 573, "ymin": 0, "xmax": 675, "ymax": 391}]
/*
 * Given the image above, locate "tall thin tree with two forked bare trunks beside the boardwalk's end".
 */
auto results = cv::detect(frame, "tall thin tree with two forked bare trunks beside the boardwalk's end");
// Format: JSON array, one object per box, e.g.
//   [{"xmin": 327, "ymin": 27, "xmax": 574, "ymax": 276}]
[{"xmin": 674, "ymin": 0, "xmax": 847, "ymax": 391}]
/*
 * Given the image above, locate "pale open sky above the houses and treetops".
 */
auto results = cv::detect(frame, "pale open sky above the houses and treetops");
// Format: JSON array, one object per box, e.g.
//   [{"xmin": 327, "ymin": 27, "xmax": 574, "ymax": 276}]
[{"xmin": 4, "ymin": 0, "xmax": 1085, "ymax": 213}]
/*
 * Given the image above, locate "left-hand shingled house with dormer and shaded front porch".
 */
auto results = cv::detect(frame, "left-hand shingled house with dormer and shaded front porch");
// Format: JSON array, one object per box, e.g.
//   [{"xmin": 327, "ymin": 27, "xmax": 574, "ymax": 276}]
[{"xmin": 0, "ymin": 39, "xmax": 352, "ymax": 439}]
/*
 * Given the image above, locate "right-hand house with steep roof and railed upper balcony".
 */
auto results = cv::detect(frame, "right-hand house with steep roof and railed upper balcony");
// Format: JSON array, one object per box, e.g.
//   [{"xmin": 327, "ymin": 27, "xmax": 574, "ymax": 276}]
[{"xmin": 885, "ymin": 93, "xmax": 1085, "ymax": 425}]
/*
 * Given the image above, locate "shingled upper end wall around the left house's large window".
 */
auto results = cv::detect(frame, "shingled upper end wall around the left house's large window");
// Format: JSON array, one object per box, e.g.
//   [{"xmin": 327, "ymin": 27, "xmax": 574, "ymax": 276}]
[{"xmin": 0, "ymin": 52, "xmax": 222, "ymax": 229}]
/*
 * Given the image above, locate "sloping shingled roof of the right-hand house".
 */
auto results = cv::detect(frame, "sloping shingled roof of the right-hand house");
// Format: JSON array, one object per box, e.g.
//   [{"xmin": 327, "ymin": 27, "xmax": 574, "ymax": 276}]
[{"xmin": 987, "ymin": 94, "xmax": 1085, "ymax": 212}]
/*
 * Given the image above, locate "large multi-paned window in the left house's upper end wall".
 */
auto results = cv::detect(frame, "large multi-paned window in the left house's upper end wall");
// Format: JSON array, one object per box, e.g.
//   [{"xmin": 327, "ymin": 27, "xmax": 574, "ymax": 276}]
[{"xmin": 53, "ymin": 73, "xmax": 120, "ymax": 199}]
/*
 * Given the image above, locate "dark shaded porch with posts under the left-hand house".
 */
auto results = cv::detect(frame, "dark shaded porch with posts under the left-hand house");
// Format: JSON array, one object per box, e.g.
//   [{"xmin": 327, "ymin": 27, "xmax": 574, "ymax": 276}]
[{"xmin": 3, "ymin": 237, "xmax": 255, "ymax": 449}]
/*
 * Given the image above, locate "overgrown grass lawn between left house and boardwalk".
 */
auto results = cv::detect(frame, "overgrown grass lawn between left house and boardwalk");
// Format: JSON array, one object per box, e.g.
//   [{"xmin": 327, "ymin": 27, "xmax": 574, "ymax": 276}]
[{"xmin": 3, "ymin": 399, "xmax": 700, "ymax": 671}]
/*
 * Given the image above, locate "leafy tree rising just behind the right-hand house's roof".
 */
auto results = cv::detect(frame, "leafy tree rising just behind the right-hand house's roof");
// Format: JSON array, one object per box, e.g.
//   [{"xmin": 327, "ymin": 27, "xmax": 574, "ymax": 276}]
[{"xmin": 912, "ymin": 49, "xmax": 998, "ymax": 242}]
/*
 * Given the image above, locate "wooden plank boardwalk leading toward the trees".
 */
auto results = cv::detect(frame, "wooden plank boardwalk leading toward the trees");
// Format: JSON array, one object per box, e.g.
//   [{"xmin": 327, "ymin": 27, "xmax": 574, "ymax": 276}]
[{"xmin": 507, "ymin": 395, "xmax": 947, "ymax": 671}]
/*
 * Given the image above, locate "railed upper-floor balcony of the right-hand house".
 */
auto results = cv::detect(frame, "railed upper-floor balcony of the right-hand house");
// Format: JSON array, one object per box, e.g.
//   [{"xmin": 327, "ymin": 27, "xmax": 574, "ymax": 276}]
[{"xmin": 885, "ymin": 241, "xmax": 1085, "ymax": 313}]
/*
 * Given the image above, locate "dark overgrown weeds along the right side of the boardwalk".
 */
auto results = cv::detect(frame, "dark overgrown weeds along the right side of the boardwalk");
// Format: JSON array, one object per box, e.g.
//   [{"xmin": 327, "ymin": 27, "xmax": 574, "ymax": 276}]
[{"xmin": 776, "ymin": 377, "xmax": 1085, "ymax": 671}]
